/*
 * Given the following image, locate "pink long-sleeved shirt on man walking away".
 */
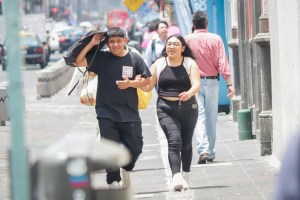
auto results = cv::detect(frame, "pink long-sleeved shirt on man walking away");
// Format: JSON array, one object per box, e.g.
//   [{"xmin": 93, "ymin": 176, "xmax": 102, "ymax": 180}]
[{"xmin": 184, "ymin": 29, "xmax": 231, "ymax": 79}]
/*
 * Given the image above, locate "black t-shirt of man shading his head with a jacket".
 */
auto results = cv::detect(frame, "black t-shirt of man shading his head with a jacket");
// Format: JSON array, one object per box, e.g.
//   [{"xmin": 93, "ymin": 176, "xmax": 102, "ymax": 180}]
[{"xmin": 86, "ymin": 51, "xmax": 151, "ymax": 122}]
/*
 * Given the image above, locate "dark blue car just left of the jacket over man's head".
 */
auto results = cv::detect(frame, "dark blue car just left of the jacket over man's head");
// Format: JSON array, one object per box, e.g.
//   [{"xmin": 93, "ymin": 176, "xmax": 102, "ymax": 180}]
[{"xmin": 59, "ymin": 27, "xmax": 86, "ymax": 53}]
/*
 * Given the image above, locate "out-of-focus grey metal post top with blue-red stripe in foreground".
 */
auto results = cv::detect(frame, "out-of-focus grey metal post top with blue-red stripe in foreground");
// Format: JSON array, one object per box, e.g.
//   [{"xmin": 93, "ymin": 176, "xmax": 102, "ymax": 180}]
[{"xmin": 31, "ymin": 134, "xmax": 133, "ymax": 200}]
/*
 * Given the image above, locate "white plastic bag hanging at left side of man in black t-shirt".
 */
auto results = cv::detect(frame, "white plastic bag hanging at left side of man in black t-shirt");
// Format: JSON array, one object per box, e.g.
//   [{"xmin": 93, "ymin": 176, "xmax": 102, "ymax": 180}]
[{"xmin": 80, "ymin": 75, "xmax": 98, "ymax": 106}]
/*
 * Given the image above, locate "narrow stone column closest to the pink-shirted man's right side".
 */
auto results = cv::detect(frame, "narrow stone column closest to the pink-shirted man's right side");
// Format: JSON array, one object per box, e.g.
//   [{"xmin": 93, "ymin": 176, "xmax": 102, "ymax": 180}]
[{"xmin": 228, "ymin": 0, "xmax": 241, "ymax": 122}]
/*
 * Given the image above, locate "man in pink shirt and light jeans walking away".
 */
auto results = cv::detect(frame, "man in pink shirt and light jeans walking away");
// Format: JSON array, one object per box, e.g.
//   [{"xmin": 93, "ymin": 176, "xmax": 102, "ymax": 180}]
[{"xmin": 184, "ymin": 11, "xmax": 235, "ymax": 164}]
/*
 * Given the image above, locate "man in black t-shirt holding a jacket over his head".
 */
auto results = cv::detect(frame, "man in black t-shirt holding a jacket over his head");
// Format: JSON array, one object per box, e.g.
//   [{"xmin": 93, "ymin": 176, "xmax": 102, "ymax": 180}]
[{"xmin": 74, "ymin": 27, "xmax": 151, "ymax": 189}]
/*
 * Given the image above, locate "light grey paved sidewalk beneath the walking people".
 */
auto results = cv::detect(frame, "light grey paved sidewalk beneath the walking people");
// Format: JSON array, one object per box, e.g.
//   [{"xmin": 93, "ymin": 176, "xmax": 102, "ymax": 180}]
[{"xmin": 0, "ymin": 84, "xmax": 278, "ymax": 200}]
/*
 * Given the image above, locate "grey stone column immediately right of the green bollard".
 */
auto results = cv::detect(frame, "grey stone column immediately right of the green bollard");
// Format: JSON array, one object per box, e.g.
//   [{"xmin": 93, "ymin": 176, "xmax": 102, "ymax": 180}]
[{"xmin": 254, "ymin": 0, "xmax": 273, "ymax": 156}]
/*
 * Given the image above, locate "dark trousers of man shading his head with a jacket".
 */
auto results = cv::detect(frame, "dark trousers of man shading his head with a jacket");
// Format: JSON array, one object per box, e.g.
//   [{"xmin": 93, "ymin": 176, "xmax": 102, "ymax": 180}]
[{"xmin": 98, "ymin": 118, "xmax": 143, "ymax": 184}]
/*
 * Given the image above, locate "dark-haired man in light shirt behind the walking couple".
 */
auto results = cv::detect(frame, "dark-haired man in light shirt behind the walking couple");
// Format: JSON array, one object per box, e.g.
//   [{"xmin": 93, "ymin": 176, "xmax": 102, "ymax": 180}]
[{"xmin": 145, "ymin": 21, "xmax": 168, "ymax": 68}]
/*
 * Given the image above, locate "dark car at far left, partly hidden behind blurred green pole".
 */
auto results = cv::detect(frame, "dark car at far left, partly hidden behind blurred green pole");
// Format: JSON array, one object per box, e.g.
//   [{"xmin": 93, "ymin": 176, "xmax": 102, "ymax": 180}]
[{"xmin": 1, "ymin": 31, "xmax": 48, "ymax": 71}]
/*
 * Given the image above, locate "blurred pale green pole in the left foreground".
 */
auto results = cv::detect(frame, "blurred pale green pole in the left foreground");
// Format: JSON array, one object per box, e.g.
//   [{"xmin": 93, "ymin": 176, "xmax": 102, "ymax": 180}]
[{"xmin": 2, "ymin": 0, "xmax": 30, "ymax": 200}]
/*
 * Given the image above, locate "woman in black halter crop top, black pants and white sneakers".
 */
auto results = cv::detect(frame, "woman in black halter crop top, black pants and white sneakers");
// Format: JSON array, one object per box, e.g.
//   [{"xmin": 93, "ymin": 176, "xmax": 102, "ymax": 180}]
[{"xmin": 141, "ymin": 35, "xmax": 201, "ymax": 191}]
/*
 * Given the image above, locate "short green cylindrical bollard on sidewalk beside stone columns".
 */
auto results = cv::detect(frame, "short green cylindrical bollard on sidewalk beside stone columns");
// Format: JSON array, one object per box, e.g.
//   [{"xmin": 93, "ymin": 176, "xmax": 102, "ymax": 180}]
[{"xmin": 237, "ymin": 109, "xmax": 253, "ymax": 140}]
